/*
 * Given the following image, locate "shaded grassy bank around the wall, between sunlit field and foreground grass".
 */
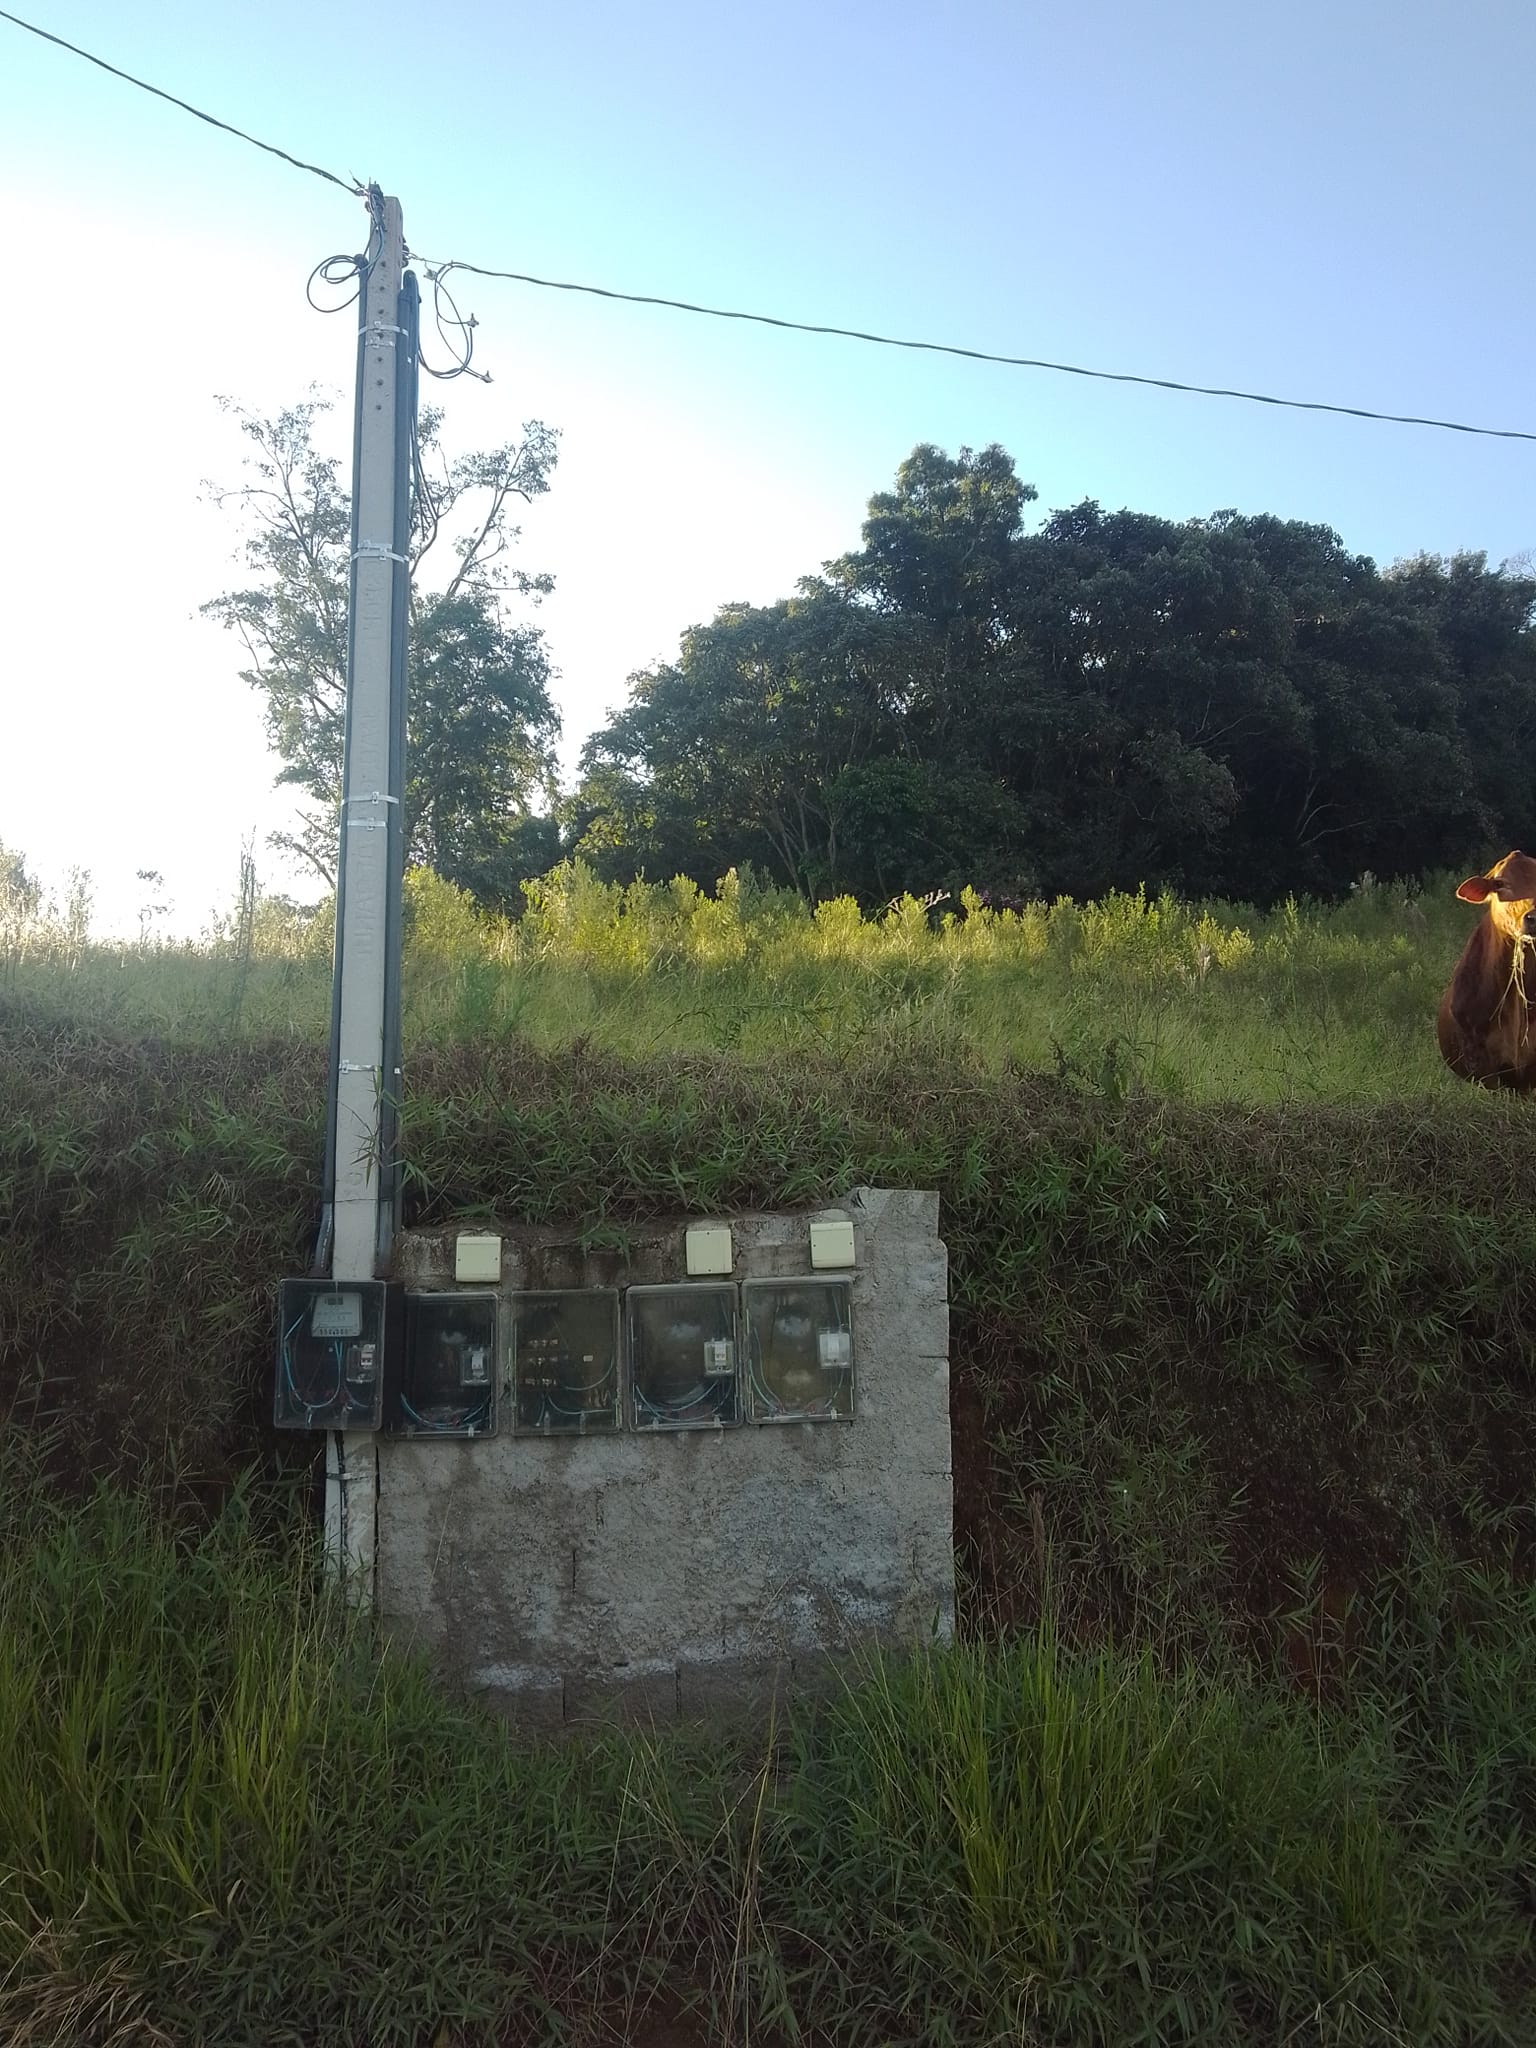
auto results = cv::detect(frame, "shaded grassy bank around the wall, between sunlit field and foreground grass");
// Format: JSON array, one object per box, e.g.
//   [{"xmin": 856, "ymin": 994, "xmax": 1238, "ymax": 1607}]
[{"xmin": 0, "ymin": 1008, "xmax": 1536, "ymax": 1630}]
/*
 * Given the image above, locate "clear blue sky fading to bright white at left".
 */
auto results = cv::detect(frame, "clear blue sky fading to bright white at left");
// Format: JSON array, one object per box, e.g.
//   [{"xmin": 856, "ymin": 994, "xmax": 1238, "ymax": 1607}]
[{"xmin": 0, "ymin": 0, "xmax": 1536, "ymax": 936}]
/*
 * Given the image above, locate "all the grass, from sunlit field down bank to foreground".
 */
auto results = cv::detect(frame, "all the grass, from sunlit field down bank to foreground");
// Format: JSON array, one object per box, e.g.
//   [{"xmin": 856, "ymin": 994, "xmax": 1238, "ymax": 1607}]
[{"xmin": 0, "ymin": 870, "xmax": 1536, "ymax": 2048}]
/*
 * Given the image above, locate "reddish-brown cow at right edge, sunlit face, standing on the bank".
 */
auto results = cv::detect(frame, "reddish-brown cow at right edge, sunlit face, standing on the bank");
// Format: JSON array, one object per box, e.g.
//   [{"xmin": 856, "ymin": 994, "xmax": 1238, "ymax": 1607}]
[{"xmin": 1436, "ymin": 852, "xmax": 1536, "ymax": 1090}]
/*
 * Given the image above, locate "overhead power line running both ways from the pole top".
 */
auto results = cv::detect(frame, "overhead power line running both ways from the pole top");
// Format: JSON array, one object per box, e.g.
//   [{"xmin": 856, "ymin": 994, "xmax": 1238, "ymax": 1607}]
[{"xmin": 0, "ymin": 8, "xmax": 1536, "ymax": 440}]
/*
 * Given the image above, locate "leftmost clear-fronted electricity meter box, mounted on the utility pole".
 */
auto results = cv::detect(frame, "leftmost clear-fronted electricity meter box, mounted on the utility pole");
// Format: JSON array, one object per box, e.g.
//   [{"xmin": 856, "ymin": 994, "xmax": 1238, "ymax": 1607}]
[{"xmin": 272, "ymin": 1280, "xmax": 401, "ymax": 1430}]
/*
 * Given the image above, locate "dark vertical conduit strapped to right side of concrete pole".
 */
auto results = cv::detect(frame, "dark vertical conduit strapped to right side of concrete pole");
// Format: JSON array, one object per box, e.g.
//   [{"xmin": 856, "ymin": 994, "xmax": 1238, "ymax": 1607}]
[{"xmin": 377, "ymin": 270, "xmax": 422, "ymax": 1266}]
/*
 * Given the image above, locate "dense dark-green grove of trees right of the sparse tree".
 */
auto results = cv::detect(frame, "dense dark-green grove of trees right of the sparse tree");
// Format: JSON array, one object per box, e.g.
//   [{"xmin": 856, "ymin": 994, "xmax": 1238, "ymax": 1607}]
[{"xmin": 569, "ymin": 446, "xmax": 1536, "ymax": 903}]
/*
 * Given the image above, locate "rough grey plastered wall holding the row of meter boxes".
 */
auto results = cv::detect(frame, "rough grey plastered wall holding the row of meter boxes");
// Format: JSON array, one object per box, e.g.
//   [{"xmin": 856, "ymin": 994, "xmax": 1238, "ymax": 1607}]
[{"xmin": 377, "ymin": 1188, "xmax": 954, "ymax": 1726}]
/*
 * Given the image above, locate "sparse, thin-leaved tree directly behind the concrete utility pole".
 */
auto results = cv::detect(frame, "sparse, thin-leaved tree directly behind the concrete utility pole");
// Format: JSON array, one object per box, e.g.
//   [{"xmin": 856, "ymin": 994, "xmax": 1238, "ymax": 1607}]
[{"xmin": 203, "ymin": 393, "xmax": 559, "ymax": 903}]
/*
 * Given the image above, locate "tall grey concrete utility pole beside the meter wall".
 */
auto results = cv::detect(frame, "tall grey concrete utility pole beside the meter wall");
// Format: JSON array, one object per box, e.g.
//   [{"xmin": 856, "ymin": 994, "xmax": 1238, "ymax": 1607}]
[{"xmin": 326, "ymin": 186, "xmax": 414, "ymax": 1602}]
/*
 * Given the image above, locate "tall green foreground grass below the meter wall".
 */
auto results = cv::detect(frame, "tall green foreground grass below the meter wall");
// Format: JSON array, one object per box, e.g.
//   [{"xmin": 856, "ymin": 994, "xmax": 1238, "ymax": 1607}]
[{"xmin": 0, "ymin": 1450, "xmax": 1536, "ymax": 2048}]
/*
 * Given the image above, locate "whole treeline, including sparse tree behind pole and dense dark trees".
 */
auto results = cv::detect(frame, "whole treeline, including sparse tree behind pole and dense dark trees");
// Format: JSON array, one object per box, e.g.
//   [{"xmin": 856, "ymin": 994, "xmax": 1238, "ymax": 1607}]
[{"xmin": 205, "ymin": 419, "xmax": 1536, "ymax": 913}]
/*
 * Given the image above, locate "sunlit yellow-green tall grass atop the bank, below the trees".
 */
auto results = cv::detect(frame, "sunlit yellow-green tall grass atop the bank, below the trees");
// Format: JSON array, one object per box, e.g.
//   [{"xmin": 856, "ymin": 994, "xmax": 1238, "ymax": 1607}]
[{"xmin": 8, "ymin": 864, "xmax": 1470, "ymax": 1102}]
